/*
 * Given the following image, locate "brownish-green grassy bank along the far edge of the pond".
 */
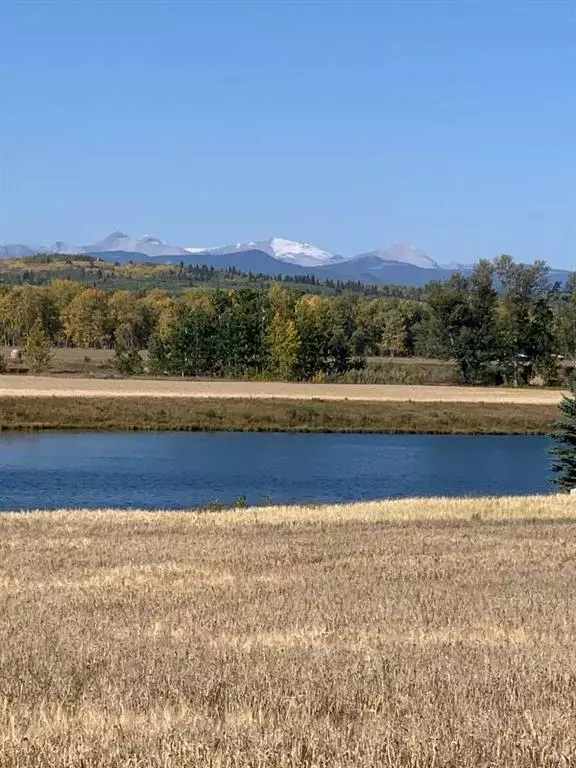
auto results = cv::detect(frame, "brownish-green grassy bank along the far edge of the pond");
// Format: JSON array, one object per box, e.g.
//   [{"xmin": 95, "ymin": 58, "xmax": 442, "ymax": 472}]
[{"xmin": 0, "ymin": 397, "xmax": 557, "ymax": 434}]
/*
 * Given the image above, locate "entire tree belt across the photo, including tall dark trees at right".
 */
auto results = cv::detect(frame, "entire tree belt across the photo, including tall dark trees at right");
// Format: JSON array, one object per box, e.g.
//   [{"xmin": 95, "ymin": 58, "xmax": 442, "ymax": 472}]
[{"xmin": 0, "ymin": 256, "xmax": 576, "ymax": 385}]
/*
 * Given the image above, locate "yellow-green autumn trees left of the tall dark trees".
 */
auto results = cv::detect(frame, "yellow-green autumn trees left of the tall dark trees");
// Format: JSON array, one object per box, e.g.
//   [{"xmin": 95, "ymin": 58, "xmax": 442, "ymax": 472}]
[{"xmin": 0, "ymin": 280, "xmax": 422, "ymax": 379}]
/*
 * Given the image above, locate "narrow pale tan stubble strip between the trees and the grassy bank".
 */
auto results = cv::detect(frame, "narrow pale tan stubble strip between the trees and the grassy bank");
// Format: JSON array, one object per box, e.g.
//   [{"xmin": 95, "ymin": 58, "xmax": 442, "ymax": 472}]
[{"xmin": 0, "ymin": 376, "xmax": 562, "ymax": 405}]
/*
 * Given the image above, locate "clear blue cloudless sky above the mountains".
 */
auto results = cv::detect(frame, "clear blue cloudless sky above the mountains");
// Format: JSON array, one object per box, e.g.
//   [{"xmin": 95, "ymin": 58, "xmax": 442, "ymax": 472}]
[{"xmin": 0, "ymin": 0, "xmax": 576, "ymax": 268}]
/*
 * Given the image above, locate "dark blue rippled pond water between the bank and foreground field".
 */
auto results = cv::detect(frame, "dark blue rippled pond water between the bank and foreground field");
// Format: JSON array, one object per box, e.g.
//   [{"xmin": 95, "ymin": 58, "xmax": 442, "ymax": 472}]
[{"xmin": 0, "ymin": 432, "xmax": 552, "ymax": 510}]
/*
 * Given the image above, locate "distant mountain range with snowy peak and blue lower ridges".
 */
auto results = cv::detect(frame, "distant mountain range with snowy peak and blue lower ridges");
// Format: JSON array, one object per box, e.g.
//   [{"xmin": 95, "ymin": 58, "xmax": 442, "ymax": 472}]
[{"xmin": 0, "ymin": 231, "xmax": 568, "ymax": 286}]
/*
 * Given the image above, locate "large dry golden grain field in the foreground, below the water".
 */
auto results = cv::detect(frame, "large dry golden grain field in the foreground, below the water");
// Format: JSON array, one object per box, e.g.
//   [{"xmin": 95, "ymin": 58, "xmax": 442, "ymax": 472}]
[{"xmin": 0, "ymin": 496, "xmax": 576, "ymax": 768}]
